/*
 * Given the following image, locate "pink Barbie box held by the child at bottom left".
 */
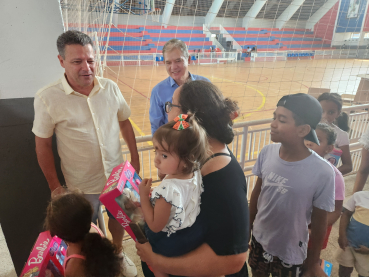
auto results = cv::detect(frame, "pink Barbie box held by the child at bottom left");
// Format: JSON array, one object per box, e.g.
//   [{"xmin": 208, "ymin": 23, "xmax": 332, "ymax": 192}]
[{"xmin": 20, "ymin": 231, "xmax": 67, "ymax": 277}]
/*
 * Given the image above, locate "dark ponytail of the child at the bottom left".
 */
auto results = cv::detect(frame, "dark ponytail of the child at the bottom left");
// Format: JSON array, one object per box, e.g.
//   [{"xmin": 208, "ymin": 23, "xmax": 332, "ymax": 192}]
[{"xmin": 81, "ymin": 233, "xmax": 122, "ymax": 277}]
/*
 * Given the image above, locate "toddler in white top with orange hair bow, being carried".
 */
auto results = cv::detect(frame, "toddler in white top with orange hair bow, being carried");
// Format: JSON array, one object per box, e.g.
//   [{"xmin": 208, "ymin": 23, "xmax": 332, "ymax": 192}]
[{"xmin": 139, "ymin": 114, "xmax": 209, "ymax": 277}]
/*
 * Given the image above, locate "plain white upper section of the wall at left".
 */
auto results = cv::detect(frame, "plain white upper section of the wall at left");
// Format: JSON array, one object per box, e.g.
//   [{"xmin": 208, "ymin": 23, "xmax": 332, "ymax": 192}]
[{"xmin": 0, "ymin": 0, "xmax": 64, "ymax": 99}]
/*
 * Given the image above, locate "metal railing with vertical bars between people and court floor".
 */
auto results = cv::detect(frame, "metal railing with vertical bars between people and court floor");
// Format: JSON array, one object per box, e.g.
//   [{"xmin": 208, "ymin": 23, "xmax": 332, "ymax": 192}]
[{"xmin": 121, "ymin": 104, "xmax": 369, "ymax": 193}]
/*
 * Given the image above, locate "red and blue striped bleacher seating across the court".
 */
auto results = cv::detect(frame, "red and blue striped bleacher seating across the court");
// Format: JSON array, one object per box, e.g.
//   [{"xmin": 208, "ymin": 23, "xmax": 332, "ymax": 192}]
[{"xmin": 88, "ymin": 25, "xmax": 333, "ymax": 62}]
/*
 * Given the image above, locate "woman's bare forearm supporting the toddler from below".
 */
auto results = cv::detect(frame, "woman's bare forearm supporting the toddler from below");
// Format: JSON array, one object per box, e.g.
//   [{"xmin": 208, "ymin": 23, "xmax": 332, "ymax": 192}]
[{"xmin": 136, "ymin": 242, "xmax": 247, "ymax": 276}]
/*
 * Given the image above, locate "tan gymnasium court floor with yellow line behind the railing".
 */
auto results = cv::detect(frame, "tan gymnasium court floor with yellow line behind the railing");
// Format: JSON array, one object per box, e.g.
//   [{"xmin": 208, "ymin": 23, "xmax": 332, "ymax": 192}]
[{"xmin": 104, "ymin": 59, "xmax": 369, "ymax": 136}]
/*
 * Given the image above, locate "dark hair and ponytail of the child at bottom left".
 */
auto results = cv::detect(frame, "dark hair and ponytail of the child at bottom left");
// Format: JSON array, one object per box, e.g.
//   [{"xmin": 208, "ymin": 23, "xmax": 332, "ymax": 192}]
[{"xmin": 45, "ymin": 193, "xmax": 122, "ymax": 277}]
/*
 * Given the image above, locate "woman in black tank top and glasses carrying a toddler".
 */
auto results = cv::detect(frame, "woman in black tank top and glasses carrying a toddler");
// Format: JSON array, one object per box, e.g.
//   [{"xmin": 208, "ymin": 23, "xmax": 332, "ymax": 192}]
[{"xmin": 136, "ymin": 81, "xmax": 249, "ymax": 276}]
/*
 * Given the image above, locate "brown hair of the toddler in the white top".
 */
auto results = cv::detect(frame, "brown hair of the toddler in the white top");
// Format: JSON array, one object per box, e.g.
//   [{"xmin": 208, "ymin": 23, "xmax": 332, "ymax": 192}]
[{"xmin": 153, "ymin": 113, "xmax": 209, "ymax": 174}]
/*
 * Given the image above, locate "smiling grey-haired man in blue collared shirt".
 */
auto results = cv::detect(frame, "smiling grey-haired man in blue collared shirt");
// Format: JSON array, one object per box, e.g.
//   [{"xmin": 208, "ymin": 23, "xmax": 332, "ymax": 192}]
[{"xmin": 149, "ymin": 38, "xmax": 210, "ymax": 134}]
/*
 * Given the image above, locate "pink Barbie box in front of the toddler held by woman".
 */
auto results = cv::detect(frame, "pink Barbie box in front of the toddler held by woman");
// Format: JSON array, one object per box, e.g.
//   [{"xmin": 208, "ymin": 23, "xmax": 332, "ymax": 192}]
[{"xmin": 99, "ymin": 161, "xmax": 143, "ymax": 241}]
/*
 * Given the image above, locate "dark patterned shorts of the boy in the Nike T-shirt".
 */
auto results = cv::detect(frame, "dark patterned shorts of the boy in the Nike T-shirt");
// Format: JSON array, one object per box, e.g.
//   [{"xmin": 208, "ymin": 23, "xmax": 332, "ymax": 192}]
[{"xmin": 249, "ymin": 236, "xmax": 302, "ymax": 277}]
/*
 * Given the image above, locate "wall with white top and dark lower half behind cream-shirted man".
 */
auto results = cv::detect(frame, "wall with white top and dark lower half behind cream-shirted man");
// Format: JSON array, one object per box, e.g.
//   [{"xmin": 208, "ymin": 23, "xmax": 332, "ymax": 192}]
[{"xmin": 0, "ymin": 0, "xmax": 64, "ymax": 275}]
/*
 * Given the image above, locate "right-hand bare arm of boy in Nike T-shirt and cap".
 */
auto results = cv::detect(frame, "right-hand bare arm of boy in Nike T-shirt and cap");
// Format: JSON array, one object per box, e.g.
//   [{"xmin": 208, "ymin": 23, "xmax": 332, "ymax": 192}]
[{"xmin": 303, "ymin": 206, "xmax": 328, "ymax": 277}]
